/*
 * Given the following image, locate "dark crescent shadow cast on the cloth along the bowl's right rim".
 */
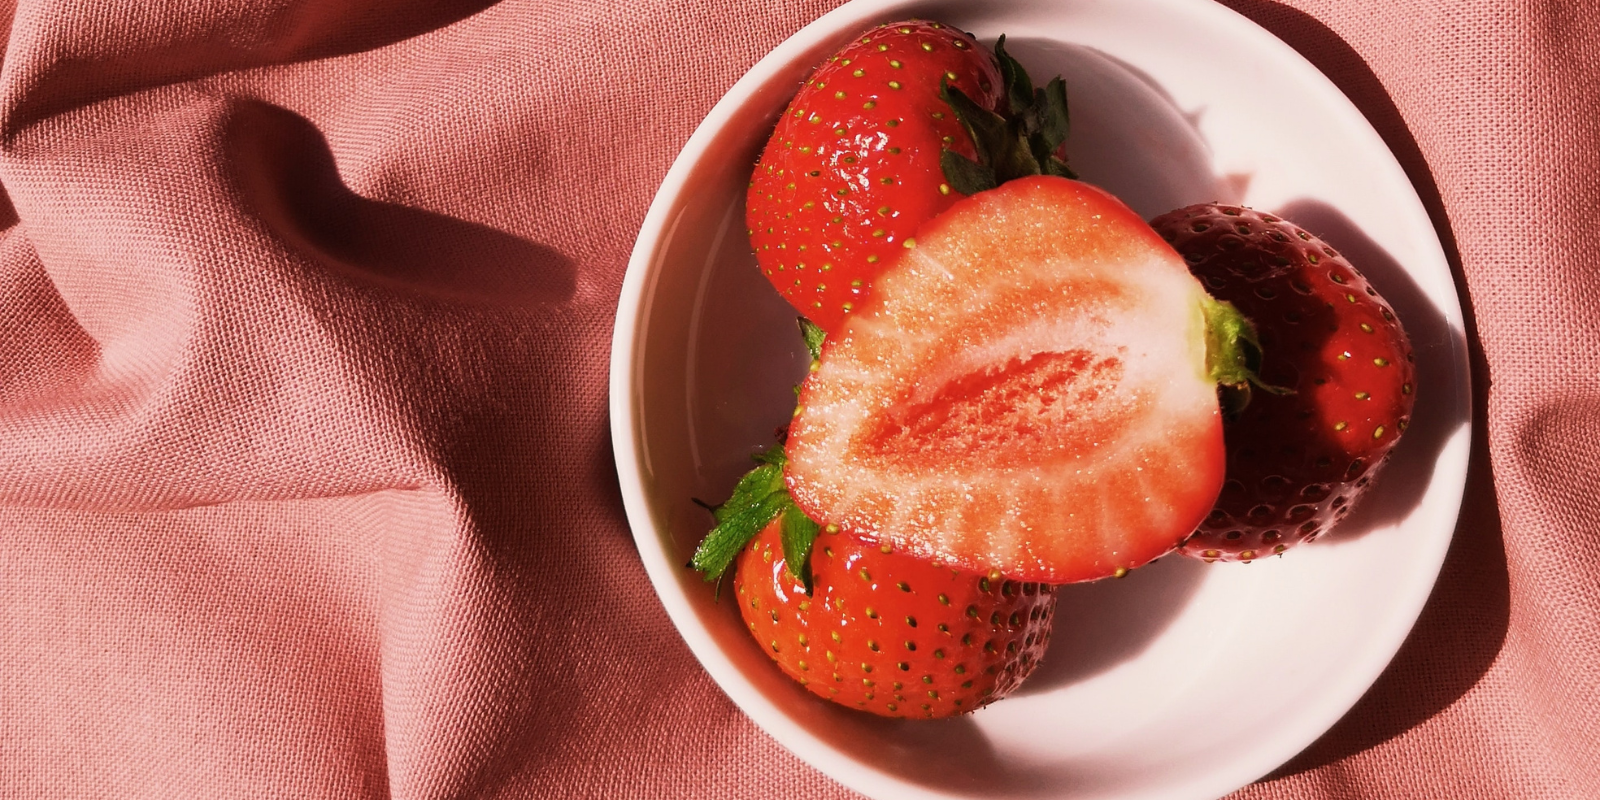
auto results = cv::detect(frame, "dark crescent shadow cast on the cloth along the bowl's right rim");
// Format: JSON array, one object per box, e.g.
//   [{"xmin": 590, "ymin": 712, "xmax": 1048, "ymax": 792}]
[{"xmin": 1221, "ymin": 0, "xmax": 1510, "ymax": 781}]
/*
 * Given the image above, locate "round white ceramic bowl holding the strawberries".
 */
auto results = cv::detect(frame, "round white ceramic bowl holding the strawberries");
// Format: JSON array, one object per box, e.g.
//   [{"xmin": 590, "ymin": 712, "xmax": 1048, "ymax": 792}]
[{"xmin": 611, "ymin": 0, "xmax": 1470, "ymax": 800}]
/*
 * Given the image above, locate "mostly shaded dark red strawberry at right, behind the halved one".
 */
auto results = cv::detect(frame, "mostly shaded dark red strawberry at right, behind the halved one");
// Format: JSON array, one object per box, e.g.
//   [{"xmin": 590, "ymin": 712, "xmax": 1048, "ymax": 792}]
[{"xmin": 1150, "ymin": 205, "xmax": 1416, "ymax": 562}]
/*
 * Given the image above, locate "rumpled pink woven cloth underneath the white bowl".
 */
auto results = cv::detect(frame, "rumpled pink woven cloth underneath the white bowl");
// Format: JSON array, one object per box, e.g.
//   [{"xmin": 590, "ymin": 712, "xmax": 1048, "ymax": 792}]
[{"xmin": 0, "ymin": 0, "xmax": 1600, "ymax": 800}]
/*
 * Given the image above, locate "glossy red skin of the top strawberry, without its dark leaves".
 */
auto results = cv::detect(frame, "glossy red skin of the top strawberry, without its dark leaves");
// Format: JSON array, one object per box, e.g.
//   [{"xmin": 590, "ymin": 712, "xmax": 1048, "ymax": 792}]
[{"xmin": 746, "ymin": 21, "xmax": 1002, "ymax": 331}]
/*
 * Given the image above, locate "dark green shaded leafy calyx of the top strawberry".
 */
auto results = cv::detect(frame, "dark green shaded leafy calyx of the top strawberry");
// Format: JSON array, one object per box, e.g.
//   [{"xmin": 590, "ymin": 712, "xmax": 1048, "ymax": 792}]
[{"xmin": 939, "ymin": 37, "xmax": 1077, "ymax": 195}]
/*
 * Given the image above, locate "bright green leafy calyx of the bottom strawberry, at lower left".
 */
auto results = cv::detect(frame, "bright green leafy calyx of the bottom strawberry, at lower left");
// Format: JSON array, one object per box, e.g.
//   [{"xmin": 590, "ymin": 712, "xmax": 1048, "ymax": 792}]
[{"xmin": 690, "ymin": 317, "xmax": 827, "ymax": 594}]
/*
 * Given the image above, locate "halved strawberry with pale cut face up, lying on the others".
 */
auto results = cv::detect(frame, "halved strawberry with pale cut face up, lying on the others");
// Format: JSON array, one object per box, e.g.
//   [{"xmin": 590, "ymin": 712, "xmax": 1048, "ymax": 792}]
[{"xmin": 786, "ymin": 176, "xmax": 1248, "ymax": 584}]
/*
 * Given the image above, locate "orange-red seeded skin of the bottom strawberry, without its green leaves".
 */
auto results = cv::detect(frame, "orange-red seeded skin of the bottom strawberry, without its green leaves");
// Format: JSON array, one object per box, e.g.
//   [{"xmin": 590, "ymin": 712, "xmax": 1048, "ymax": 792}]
[{"xmin": 734, "ymin": 522, "xmax": 1056, "ymax": 718}]
